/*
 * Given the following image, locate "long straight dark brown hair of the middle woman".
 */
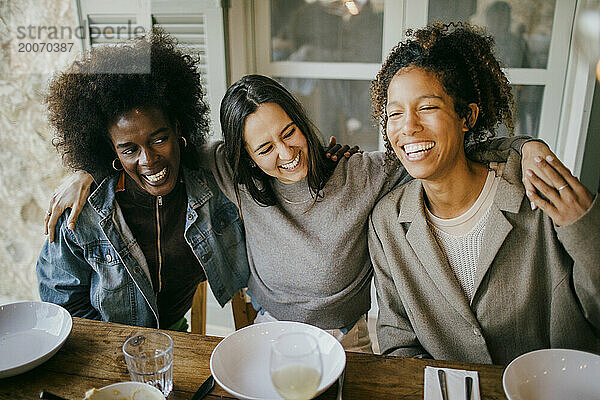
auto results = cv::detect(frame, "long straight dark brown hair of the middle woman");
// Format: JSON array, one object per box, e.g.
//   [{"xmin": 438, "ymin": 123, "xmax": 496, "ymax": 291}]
[{"xmin": 221, "ymin": 75, "xmax": 332, "ymax": 209}]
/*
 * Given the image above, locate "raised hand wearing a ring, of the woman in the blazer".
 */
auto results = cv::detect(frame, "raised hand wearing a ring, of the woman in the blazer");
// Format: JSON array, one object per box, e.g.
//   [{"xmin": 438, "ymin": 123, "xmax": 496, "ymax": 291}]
[{"xmin": 525, "ymin": 156, "xmax": 593, "ymax": 226}]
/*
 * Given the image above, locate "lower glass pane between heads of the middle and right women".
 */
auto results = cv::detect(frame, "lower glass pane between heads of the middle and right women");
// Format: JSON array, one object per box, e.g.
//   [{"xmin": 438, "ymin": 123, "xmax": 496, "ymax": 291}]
[{"xmin": 275, "ymin": 78, "xmax": 379, "ymax": 151}]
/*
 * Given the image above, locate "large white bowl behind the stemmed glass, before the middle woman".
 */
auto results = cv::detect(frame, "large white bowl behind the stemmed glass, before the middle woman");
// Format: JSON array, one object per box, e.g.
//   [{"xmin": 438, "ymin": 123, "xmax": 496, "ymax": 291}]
[{"xmin": 210, "ymin": 321, "xmax": 346, "ymax": 400}]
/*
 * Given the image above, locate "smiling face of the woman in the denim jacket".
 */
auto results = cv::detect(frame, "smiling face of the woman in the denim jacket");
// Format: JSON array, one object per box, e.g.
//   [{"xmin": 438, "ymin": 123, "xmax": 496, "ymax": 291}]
[{"xmin": 108, "ymin": 108, "xmax": 180, "ymax": 196}]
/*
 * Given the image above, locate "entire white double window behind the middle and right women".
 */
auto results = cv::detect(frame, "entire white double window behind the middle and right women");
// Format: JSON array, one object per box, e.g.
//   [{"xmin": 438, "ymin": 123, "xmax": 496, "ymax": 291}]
[{"xmin": 243, "ymin": 0, "xmax": 593, "ymax": 172}]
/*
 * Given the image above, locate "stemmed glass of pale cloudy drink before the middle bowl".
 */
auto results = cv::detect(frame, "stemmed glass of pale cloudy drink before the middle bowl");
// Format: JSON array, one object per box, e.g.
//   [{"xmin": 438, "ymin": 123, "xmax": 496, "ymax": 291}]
[{"xmin": 270, "ymin": 332, "xmax": 323, "ymax": 400}]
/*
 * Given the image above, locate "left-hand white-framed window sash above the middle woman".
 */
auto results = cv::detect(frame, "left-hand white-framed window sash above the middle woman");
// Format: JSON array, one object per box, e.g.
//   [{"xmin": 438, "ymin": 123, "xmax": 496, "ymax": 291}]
[{"xmin": 254, "ymin": 0, "xmax": 403, "ymax": 150}]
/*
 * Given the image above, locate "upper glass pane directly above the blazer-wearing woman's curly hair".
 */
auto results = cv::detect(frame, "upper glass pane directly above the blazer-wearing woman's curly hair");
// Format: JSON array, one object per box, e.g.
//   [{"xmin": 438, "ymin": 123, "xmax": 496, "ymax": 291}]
[{"xmin": 428, "ymin": 0, "xmax": 556, "ymax": 68}]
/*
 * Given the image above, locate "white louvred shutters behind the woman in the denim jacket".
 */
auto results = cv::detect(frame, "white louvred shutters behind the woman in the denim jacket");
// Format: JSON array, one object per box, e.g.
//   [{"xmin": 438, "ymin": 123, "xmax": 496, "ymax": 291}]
[{"xmin": 76, "ymin": 0, "xmax": 227, "ymax": 135}]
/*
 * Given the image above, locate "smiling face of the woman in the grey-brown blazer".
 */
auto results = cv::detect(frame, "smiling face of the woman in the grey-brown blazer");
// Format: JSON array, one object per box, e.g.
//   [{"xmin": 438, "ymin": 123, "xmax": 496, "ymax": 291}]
[{"xmin": 386, "ymin": 67, "xmax": 478, "ymax": 180}]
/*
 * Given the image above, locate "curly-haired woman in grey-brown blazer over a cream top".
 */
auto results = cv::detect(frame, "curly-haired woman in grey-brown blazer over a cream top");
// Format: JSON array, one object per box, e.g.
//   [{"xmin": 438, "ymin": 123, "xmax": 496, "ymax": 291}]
[{"xmin": 369, "ymin": 24, "xmax": 600, "ymax": 364}]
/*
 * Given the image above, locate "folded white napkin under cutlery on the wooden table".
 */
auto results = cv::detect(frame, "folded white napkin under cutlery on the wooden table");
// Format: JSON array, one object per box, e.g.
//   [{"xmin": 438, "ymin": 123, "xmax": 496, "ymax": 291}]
[{"xmin": 425, "ymin": 367, "xmax": 481, "ymax": 400}]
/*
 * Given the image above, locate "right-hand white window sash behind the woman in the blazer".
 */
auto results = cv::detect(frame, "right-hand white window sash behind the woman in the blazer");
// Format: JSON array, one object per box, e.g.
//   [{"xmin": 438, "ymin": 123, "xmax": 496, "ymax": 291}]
[{"xmin": 407, "ymin": 0, "xmax": 575, "ymax": 152}]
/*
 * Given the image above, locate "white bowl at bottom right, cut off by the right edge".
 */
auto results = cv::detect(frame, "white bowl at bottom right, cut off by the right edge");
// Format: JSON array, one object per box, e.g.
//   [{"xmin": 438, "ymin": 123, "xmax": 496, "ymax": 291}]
[{"xmin": 502, "ymin": 349, "xmax": 600, "ymax": 400}]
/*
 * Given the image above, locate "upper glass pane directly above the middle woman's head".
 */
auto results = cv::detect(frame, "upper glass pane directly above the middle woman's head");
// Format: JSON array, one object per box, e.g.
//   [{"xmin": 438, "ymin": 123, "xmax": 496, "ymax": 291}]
[{"xmin": 271, "ymin": 0, "xmax": 383, "ymax": 63}]
